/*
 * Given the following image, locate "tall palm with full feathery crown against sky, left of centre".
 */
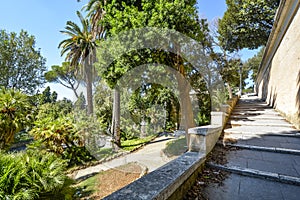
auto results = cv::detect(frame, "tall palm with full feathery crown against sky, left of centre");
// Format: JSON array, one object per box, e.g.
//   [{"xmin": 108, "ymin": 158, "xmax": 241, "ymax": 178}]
[{"xmin": 58, "ymin": 11, "xmax": 97, "ymax": 115}]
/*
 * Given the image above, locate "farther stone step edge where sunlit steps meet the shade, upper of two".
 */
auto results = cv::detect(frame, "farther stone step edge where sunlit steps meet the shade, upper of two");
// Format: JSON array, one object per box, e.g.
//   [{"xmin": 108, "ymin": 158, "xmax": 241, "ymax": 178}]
[{"xmin": 217, "ymin": 142, "xmax": 300, "ymax": 155}]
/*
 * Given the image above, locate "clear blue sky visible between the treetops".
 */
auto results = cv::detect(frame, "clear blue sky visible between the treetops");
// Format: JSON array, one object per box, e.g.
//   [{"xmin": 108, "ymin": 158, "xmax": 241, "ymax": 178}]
[{"xmin": 0, "ymin": 0, "xmax": 253, "ymax": 99}]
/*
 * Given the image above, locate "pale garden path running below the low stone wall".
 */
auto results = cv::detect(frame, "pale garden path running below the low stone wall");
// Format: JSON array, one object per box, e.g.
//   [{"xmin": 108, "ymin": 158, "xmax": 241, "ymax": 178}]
[{"xmin": 74, "ymin": 136, "xmax": 176, "ymax": 179}]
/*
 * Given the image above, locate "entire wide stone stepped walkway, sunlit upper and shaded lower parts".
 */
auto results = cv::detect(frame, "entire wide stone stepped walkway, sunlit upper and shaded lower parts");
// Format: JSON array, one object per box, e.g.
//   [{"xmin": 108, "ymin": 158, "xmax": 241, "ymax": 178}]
[{"xmin": 199, "ymin": 96, "xmax": 300, "ymax": 200}]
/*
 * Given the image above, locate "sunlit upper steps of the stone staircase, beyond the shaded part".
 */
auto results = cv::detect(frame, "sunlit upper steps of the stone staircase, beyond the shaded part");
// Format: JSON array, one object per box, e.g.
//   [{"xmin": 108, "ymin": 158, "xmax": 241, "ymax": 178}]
[{"xmin": 224, "ymin": 97, "xmax": 299, "ymax": 142}]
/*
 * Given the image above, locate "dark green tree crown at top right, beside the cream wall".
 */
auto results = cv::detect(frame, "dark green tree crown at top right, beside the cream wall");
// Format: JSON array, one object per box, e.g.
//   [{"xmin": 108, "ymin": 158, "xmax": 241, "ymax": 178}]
[{"xmin": 219, "ymin": 0, "xmax": 280, "ymax": 51}]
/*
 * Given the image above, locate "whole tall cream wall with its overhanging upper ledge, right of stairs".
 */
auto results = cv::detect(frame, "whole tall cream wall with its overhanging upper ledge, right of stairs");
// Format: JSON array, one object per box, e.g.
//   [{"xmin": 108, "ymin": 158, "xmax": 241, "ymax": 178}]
[{"xmin": 256, "ymin": 0, "xmax": 300, "ymax": 128}]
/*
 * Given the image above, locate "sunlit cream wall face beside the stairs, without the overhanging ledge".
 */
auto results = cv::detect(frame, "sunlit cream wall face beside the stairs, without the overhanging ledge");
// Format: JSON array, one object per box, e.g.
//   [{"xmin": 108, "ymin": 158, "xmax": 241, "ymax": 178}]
[{"xmin": 258, "ymin": 1, "xmax": 300, "ymax": 128}]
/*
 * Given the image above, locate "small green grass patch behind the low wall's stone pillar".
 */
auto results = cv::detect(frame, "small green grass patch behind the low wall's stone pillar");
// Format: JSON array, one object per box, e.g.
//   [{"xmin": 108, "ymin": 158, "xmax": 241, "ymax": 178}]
[{"xmin": 163, "ymin": 136, "xmax": 187, "ymax": 157}]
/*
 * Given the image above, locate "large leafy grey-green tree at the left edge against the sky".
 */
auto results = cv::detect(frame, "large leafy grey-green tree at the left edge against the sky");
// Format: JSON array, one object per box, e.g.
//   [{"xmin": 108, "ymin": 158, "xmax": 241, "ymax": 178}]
[{"xmin": 0, "ymin": 30, "xmax": 46, "ymax": 94}]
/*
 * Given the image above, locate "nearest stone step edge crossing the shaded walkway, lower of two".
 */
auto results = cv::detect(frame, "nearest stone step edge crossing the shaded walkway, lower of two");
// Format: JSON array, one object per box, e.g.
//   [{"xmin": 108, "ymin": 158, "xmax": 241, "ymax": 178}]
[{"xmin": 207, "ymin": 163, "xmax": 300, "ymax": 186}]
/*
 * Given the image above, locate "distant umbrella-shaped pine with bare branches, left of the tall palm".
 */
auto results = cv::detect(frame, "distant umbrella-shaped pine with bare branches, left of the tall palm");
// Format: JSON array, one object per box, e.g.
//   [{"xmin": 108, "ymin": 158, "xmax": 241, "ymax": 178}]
[{"xmin": 45, "ymin": 62, "xmax": 80, "ymax": 98}]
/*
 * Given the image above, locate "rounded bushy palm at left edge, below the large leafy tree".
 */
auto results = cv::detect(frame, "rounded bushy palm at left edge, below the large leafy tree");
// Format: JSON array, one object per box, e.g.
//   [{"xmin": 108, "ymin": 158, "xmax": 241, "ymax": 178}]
[{"xmin": 0, "ymin": 88, "xmax": 33, "ymax": 149}]
